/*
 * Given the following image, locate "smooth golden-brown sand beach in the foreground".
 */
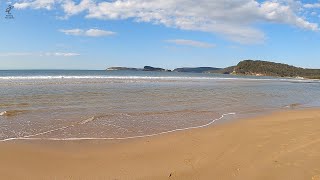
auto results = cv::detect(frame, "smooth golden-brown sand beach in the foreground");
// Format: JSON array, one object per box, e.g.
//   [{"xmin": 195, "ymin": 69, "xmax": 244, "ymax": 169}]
[{"xmin": 0, "ymin": 109, "xmax": 320, "ymax": 180}]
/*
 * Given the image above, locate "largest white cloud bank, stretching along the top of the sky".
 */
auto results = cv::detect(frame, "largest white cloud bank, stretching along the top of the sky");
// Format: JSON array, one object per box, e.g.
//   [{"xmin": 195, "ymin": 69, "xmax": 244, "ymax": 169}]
[{"xmin": 13, "ymin": 0, "xmax": 319, "ymax": 43}]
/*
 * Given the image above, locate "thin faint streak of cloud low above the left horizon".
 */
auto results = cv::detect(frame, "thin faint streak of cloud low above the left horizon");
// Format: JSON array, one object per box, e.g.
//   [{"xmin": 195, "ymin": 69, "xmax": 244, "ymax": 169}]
[{"xmin": 0, "ymin": 52, "xmax": 80, "ymax": 57}]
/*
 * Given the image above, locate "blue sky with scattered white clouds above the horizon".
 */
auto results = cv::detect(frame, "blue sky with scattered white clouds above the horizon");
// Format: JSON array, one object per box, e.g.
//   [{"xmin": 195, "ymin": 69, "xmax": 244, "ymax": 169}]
[{"xmin": 0, "ymin": 0, "xmax": 320, "ymax": 69}]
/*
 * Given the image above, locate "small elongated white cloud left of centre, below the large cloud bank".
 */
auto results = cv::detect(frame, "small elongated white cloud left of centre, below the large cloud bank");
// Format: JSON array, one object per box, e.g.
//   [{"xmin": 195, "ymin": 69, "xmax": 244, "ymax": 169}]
[{"xmin": 59, "ymin": 29, "xmax": 116, "ymax": 37}]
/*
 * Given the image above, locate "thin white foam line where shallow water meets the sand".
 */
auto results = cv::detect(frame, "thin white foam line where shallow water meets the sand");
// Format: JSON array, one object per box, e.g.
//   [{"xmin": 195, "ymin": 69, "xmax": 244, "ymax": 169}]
[{"xmin": 0, "ymin": 113, "xmax": 236, "ymax": 142}]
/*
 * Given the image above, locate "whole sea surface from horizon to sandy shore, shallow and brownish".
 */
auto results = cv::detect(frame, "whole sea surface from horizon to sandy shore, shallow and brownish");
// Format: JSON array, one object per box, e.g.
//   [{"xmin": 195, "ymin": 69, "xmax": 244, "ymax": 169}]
[{"xmin": 0, "ymin": 70, "xmax": 320, "ymax": 141}]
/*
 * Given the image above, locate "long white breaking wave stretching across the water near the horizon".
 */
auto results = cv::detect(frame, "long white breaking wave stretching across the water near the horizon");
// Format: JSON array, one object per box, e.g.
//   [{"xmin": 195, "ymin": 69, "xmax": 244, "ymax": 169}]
[{"xmin": 0, "ymin": 76, "xmax": 320, "ymax": 82}]
